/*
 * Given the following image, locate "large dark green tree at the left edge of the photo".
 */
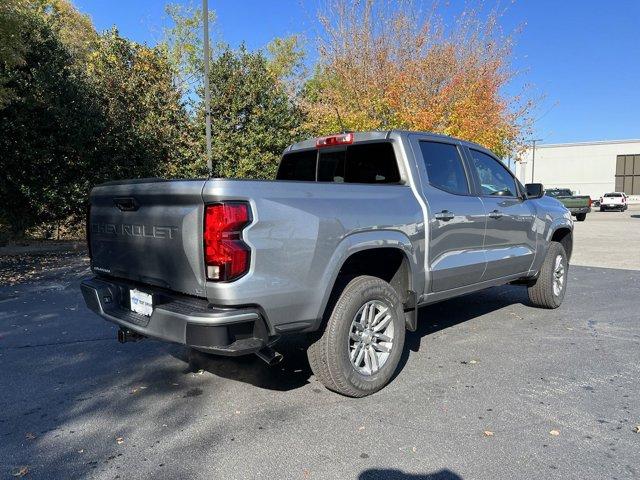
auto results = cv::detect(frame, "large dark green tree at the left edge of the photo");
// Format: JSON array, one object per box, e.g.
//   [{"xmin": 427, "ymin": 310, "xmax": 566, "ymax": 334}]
[{"xmin": 0, "ymin": 4, "xmax": 102, "ymax": 236}]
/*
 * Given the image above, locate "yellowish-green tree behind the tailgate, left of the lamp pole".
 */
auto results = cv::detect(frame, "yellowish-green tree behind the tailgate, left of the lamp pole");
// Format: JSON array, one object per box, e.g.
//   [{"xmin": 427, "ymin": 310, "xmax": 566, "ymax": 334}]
[{"xmin": 87, "ymin": 29, "xmax": 204, "ymax": 179}]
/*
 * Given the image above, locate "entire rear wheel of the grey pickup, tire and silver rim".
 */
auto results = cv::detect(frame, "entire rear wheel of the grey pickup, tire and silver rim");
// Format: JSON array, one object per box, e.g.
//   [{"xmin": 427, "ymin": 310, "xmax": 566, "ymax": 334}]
[{"xmin": 307, "ymin": 275, "xmax": 405, "ymax": 397}]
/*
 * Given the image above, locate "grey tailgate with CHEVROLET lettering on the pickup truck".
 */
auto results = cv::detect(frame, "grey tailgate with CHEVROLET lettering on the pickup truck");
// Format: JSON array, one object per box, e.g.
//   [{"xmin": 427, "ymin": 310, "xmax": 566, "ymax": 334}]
[{"xmin": 89, "ymin": 179, "xmax": 205, "ymax": 297}]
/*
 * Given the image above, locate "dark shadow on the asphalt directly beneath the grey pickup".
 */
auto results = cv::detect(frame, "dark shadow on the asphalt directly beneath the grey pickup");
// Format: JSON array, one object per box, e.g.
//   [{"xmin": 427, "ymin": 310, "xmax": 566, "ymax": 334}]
[{"xmin": 188, "ymin": 285, "xmax": 528, "ymax": 392}]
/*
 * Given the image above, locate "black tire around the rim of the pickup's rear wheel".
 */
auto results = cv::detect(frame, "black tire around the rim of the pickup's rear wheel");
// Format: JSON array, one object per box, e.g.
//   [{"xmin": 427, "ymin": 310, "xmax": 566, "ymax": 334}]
[{"xmin": 307, "ymin": 275, "xmax": 405, "ymax": 397}]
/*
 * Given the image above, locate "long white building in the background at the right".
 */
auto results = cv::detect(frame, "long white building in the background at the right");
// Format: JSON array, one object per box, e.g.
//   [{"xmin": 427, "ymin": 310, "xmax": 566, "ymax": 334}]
[{"xmin": 515, "ymin": 140, "xmax": 640, "ymax": 198}]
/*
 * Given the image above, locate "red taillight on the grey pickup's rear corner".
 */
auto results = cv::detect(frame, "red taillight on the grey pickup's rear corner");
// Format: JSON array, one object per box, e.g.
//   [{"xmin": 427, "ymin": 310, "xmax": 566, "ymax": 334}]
[{"xmin": 204, "ymin": 202, "xmax": 251, "ymax": 281}]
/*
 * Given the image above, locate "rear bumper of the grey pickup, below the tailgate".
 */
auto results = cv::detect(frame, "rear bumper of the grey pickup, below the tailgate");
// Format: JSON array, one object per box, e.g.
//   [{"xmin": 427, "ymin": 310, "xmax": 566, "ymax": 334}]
[{"xmin": 80, "ymin": 277, "xmax": 275, "ymax": 355}]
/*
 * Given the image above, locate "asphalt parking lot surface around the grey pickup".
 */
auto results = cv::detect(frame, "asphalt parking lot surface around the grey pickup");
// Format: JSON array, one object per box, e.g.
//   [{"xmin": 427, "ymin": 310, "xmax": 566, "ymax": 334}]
[{"xmin": 0, "ymin": 208, "xmax": 640, "ymax": 480}]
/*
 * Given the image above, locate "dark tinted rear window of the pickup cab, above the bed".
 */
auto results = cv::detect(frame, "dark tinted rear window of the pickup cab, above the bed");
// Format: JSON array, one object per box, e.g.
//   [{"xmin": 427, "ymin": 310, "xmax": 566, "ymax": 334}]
[{"xmin": 277, "ymin": 142, "xmax": 400, "ymax": 183}]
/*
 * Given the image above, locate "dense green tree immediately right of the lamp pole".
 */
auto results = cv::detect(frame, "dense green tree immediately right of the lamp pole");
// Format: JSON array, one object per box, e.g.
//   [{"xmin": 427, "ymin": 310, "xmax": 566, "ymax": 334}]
[{"xmin": 205, "ymin": 46, "xmax": 302, "ymax": 178}]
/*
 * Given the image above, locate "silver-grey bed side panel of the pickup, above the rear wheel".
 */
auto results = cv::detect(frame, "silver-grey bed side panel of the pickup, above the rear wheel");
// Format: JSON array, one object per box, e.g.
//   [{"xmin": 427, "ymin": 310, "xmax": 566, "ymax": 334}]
[{"xmin": 203, "ymin": 180, "xmax": 424, "ymax": 332}]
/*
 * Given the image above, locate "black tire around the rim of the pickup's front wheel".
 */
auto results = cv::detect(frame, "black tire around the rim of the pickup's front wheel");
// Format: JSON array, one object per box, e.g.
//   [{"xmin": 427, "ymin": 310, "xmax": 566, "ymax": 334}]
[{"xmin": 528, "ymin": 242, "xmax": 569, "ymax": 308}]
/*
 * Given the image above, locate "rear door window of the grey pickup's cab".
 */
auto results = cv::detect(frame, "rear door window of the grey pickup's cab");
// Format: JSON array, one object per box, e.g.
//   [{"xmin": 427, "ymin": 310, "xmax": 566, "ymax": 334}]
[{"xmin": 420, "ymin": 142, "xmax": 469, "ymax": 195}]
